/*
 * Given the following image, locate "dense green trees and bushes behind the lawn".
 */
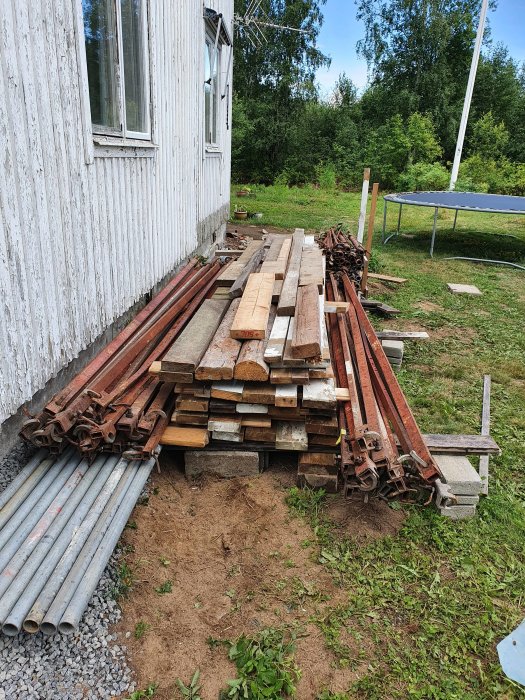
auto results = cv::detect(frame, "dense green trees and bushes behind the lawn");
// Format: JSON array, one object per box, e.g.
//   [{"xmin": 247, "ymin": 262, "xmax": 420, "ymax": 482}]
[{"xmin": 232, "ymin": 0, "xmax": 525, "ymax": 195}]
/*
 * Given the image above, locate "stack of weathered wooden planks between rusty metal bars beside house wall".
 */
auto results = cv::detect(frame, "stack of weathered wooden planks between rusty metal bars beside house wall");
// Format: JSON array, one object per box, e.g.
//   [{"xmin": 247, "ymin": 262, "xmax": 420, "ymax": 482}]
[{"xmin": 151, "ymin": 229, "xmax": 339, "ymax": 454}]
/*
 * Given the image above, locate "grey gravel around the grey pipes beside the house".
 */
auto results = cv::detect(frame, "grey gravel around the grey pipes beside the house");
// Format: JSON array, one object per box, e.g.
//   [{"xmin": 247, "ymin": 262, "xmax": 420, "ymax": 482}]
[{"xmin": 0, "ymin": 444, "xmax": 135, "ymax": 700}]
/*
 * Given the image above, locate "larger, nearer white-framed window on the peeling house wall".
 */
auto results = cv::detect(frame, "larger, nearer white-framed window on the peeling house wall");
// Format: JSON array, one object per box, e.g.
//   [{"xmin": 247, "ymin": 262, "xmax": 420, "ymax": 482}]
[{"xmin": 82, "ymin": 0, "xmax": 151, "ymax": 139}]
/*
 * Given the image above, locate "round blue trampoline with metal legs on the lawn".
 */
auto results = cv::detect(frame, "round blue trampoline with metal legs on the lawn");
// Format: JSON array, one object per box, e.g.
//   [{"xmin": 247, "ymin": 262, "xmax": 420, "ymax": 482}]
[{"xmin": 382, "ymin": 192, "xmax": 525, "ymax": 262}]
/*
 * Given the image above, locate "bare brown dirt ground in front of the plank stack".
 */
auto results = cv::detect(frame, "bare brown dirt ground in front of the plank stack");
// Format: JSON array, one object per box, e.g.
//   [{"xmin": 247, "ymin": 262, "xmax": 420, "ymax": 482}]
[{"xmin": 117, "ymin": 453, "xmax": 403, "ymax": 700}]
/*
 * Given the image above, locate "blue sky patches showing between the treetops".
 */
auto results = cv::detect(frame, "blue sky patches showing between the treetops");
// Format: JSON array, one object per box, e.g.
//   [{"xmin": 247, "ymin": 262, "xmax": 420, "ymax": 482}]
[{"xmin": 317, "ymin": 0, "xmax": 525, "ymax": 93}]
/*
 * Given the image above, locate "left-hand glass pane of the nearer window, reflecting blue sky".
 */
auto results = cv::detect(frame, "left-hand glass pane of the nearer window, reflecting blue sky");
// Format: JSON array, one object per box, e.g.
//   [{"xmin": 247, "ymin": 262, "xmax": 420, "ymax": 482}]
[{"xmin": 82, "ymin": 0, "xmax": 120, "ymax": 129}]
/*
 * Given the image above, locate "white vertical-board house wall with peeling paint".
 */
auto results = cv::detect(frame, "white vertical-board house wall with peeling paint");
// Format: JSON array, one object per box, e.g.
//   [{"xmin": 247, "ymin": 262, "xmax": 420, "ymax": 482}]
[{"xmin": 0, "ymin": 0, "xmax": 233, "ymax": 422}]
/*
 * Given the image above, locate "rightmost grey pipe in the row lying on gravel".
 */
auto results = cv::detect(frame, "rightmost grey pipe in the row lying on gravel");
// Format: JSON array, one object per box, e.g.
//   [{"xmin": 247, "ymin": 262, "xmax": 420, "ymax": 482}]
[{"xmin": 58, "ymin": 459, "xmax": 155, "ymax": 635}]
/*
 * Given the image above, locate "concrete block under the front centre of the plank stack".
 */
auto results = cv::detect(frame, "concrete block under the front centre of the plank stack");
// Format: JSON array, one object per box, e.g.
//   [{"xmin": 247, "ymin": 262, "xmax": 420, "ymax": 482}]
[{"xmin": 184, "ymin": 450, "xmax": 260, "ymax": 479}]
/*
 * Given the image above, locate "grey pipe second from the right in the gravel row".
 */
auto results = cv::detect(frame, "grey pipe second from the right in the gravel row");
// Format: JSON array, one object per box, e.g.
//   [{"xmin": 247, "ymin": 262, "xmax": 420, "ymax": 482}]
[{"xmin": 40, "ymin": 462, "xmax": 141, "ymax": 634}]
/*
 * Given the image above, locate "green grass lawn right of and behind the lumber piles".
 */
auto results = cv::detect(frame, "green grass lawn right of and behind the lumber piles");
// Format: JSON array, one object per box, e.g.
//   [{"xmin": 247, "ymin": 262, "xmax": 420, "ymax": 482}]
[{"xmin": 232, "ymin": 187, "xmax": 525, "ymax": 700}]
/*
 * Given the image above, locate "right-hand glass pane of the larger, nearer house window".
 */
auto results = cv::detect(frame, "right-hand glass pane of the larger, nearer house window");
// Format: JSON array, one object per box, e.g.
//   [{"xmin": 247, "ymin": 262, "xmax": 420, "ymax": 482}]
[{"xmin": 120, "ymin": 0, "xmax": 149, "ymax": 133}]
